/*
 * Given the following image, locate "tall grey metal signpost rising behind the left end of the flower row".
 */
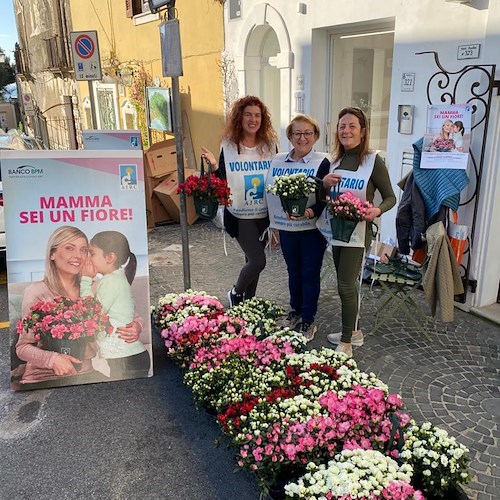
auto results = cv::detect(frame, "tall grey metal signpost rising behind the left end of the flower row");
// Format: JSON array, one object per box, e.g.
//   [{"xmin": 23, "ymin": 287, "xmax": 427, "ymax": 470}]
[{"xmin": 168, "ymin": 1, "xmax": 191, "ymax": 290}]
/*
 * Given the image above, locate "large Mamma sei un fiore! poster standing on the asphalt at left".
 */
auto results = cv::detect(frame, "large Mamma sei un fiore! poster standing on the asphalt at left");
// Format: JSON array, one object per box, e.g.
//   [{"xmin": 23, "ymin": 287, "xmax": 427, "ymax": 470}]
[{"xmin": 0, "ymin": 151, "xmax": 153, "ymax": 390}]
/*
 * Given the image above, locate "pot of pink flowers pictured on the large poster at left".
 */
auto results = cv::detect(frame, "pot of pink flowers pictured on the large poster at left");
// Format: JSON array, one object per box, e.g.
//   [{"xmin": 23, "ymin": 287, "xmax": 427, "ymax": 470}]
[{"xmin": 17, "ymin": 296, "xmax": 112, "ymax": 370}]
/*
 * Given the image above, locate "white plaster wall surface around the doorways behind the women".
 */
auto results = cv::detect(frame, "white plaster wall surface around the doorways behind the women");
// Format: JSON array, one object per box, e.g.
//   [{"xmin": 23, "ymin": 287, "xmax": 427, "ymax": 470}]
[{"xmin": 226, "ymin": 0, "xmax": 500, "ymax": 305}]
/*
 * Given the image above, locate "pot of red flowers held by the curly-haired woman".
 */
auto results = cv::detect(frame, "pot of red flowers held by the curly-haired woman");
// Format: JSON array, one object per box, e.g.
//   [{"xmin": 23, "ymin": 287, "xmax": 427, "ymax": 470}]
[{"xmin": 177, "ymin": 159, "xmax": 231, "ymax": 219}]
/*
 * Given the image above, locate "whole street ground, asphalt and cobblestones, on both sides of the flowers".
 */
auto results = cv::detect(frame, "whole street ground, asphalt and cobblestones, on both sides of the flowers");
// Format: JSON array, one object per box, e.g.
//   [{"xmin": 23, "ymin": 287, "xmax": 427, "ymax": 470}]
[{"xmin": 0, "ymin": 222, "xmax": 500, "ymax": 500}]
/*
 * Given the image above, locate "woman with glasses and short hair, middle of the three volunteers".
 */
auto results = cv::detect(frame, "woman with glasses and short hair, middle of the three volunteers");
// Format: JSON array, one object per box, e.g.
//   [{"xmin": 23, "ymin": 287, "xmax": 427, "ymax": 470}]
[{"xmin": 266, "ymin": 115, "xmax": 330, "ymax": 342}]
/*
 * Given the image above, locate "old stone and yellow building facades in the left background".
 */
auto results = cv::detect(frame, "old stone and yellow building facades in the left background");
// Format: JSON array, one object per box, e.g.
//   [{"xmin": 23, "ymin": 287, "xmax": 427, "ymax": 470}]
[{"xmin": 14, "ymin": 0, "xmax": 224, "ymax": 160}]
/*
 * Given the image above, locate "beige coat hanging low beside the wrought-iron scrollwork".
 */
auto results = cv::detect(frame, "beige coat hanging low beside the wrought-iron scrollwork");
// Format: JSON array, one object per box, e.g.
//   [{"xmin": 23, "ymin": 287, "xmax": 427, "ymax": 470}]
[{"xmin": 422, "ymin": 222, "xmax": 464, "ymax": 322}]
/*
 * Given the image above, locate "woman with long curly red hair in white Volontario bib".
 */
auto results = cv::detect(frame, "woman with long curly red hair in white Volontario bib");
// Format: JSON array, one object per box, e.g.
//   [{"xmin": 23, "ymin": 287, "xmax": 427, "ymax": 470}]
[{"xmin": 202, "ymin": 96, "xmax": 278, "ymax": 306}]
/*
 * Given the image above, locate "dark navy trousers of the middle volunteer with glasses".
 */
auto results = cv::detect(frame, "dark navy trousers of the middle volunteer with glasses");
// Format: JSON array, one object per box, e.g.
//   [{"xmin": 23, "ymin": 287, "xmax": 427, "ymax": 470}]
[{"xmin": 280, "ymin": 229, "xmax": 326, "ymax": 323}]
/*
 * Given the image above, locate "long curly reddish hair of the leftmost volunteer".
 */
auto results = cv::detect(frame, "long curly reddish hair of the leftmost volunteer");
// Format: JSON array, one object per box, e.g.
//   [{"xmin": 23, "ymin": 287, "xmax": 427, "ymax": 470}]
[{"xmin": 224, "ymin": 95, "xmax": 278, "ymax": 153}]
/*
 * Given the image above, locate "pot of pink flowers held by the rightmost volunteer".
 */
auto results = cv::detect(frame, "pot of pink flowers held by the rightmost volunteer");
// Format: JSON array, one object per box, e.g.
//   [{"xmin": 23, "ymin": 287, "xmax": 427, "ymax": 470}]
[{"xmin": 327, "ymin": 191, "xmax": 373, "ymax": 243}]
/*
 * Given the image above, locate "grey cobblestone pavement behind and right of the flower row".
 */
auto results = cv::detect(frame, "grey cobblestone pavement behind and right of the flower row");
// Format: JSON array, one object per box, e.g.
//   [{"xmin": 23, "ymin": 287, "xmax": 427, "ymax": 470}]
[{"xmin": 150, "ymin": 222, "xmax": 500, "ymax": 500}]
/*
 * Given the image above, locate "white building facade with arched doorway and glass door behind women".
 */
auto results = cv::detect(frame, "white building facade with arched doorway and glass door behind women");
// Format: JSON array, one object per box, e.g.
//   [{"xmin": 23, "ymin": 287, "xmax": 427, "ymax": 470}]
[{"xmin": 225, "ymin": 0, "xmax": 500, "ymax": 309}]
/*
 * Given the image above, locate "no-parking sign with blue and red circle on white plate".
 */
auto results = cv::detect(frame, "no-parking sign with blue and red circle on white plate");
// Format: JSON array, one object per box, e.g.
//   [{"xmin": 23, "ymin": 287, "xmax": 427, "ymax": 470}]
[{"xmin": 70, "ymin": 31, "xmax": 102, "ymax": 81}]
